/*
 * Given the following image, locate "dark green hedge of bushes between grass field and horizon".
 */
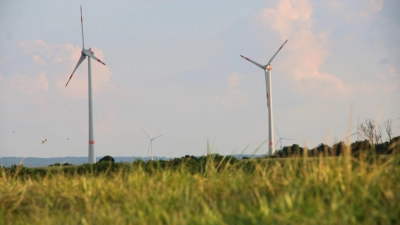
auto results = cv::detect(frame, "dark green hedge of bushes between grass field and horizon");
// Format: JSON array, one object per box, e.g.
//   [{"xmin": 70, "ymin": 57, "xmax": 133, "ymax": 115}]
[{"xmin": 0, "ymin": 137, "xmax": 400, "ymax": 179}]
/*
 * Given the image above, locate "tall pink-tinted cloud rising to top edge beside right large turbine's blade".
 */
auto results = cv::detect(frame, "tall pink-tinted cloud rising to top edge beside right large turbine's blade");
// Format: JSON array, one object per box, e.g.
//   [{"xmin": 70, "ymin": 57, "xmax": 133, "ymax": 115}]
[{"xmin": 261, "ymin": 0, "xmax": 345, "ymax": 96}]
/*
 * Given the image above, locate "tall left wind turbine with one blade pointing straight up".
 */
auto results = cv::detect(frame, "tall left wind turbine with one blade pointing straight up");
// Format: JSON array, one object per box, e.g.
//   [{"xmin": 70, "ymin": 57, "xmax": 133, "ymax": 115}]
[{"xmin": 65, "ymin": 6, "xmax": 106, "ymax": 163}]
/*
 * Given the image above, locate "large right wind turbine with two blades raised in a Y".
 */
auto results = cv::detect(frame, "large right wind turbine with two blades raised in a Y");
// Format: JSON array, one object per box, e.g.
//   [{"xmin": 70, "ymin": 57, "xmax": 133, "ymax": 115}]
[{"xmin": 240, "ymin": 40, "xmax": 288, "ymax": 155}]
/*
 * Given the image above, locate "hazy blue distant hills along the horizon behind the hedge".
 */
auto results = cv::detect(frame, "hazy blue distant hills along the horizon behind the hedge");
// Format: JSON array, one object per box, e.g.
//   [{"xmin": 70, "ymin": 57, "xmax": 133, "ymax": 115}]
[{"xmin": 0, "ymin": 154, "xmax": 265, "ymax": 167}]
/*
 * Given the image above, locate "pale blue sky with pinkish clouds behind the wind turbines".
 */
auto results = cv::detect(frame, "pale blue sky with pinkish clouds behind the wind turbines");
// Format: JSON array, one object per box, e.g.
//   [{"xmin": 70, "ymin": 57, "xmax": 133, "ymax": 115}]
[{"xmin": 0, "ymin": 0, "xmax": 400, "ymax": 158}]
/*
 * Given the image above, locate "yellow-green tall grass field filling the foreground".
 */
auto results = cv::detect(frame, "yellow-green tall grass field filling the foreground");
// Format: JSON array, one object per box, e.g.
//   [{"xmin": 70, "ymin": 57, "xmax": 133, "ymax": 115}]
[{"xmin": 0, "ymin": 151, "xmax": 400, "ymax": 224}]
